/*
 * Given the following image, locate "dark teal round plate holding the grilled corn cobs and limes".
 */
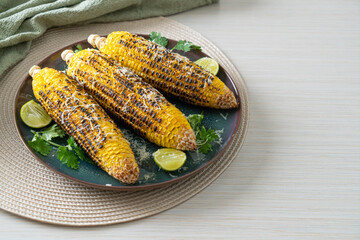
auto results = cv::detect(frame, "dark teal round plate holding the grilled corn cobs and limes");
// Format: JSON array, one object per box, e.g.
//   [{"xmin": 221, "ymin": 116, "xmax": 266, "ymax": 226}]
[{"xmin": 15, "ymin": 35, "xmax": 241, "ymax": 190}]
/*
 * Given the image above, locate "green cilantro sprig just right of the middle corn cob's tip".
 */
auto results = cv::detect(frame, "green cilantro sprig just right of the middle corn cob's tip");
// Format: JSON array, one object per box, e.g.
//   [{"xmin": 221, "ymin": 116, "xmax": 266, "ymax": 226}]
[{"xmin": 187, "ymin": 113, "xmax": 221, "ymax": 154}]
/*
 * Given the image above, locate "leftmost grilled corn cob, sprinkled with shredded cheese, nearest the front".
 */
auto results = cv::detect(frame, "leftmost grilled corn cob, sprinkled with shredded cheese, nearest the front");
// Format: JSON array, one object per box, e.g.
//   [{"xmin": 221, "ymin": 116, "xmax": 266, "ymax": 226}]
[{"xmin": 29, "ymin": 66, "xmax": 139, "ymax": 184}]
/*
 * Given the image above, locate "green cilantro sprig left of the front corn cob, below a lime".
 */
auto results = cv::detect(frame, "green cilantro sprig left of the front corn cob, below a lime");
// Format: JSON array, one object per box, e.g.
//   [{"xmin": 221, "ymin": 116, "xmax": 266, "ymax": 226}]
[{"xmin": 28, "ymin": 124, "xmax": 94, "ymax": 169}]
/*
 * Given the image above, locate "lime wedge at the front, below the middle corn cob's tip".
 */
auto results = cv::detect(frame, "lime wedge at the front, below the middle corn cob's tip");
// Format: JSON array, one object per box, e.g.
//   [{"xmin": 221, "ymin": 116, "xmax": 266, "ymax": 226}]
[{"xmin": 153, "ymin": 148, "xmax": 186, "ymax": 171}]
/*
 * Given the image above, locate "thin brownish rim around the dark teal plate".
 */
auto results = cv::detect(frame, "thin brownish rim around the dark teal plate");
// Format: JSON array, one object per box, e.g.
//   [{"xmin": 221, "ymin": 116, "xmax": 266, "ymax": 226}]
[{"xmin": 13, "ymin": 33, "xmax": 244, "ymax": 191}]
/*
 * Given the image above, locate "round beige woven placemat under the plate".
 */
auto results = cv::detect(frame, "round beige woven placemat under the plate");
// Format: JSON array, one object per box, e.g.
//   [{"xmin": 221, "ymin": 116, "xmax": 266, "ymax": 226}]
[{"xmin": 0, "ymin": 17, "xmax": 248, "ymax": 226}]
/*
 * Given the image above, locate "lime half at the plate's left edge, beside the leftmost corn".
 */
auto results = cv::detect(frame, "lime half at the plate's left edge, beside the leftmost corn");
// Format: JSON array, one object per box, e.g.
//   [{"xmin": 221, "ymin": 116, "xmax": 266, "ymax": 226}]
[{"xmin": 20, "ymin": 100, "xmax": 51, "ymax": 128}]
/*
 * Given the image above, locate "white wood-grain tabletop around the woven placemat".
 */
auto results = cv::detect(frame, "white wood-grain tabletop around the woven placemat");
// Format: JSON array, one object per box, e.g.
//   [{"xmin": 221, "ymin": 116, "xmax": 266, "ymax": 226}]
[{"xmin": 0, "ymin": 0, "xmax": 360, "ymax": 240}]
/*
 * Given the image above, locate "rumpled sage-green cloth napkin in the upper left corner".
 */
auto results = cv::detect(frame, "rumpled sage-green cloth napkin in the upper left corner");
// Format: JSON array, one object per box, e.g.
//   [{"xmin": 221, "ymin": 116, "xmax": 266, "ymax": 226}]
[{"xmin": 0, "ymin": 0, "xmax": 218, "ymax": 76}]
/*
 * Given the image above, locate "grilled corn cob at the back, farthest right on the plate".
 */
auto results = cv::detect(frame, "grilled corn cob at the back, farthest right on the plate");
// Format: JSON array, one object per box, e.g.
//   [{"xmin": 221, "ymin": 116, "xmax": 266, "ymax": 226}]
[{"xmin": 88, "ymin": 31, "xmax": 238, "ymax": 109}]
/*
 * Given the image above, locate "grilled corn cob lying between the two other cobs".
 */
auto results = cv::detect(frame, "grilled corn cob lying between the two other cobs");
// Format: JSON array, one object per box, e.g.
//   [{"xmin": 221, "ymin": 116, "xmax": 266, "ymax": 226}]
[{"xmin": 62, "ymin": 49, "xmax": 196, "ymax": 150}]
